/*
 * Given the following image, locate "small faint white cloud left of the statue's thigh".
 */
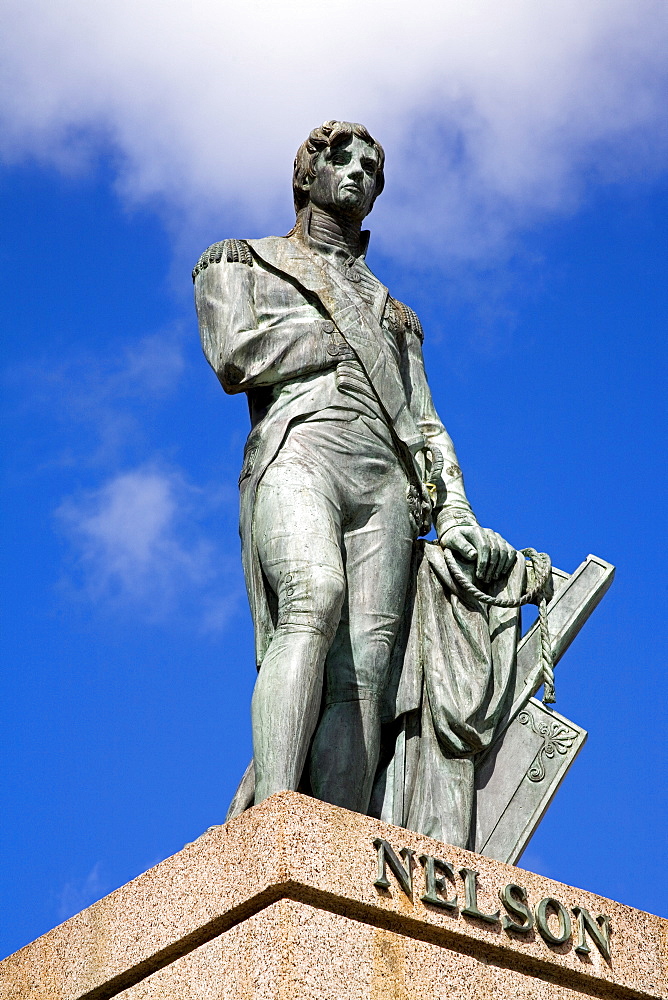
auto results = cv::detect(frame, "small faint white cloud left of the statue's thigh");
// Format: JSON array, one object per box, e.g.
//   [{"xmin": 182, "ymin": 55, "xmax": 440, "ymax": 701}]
[{"xmin": 56, "ymin": 466, "xmax": 239, "ymax": 630}]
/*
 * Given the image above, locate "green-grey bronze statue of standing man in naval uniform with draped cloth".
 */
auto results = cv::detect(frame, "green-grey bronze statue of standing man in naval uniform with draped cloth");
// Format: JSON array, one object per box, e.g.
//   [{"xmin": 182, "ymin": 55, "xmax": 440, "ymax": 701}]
[{"xmin": 194, "ymin": 121, "xmax": 521, "ymax": 845}]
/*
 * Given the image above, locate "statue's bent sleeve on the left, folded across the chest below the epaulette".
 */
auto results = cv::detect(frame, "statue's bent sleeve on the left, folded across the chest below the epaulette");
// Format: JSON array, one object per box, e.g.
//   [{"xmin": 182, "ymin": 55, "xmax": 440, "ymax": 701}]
[{"xmin": 195, "ymin": 260, "xmax": 331, "ymax": 393}]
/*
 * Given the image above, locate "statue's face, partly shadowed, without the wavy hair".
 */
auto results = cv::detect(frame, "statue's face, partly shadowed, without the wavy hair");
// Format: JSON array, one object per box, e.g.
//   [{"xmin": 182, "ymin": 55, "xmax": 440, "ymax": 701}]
[{"xmin": 308, "ymin": 135, "xmax": 379, "ymax": 221}]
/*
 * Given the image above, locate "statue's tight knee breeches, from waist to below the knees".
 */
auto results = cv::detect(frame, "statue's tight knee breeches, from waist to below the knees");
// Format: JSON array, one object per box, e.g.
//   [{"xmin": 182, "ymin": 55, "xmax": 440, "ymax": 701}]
[{"xmin": 253, "ymin": 416, "xmax": 415, "ymax": 702}]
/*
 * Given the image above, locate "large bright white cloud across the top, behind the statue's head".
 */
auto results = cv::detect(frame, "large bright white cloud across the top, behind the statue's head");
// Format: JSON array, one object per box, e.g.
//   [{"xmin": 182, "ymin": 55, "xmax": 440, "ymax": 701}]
[{"xmin": 0, "ymin": 0, "xmax": 668, "ymax": 257}]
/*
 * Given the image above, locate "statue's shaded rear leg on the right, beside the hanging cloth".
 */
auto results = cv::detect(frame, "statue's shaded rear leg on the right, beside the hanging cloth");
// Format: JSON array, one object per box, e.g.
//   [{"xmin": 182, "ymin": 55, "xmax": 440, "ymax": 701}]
[{"xmin": 310, "ymin": 459, "xmax": 415, "ymax": 812}]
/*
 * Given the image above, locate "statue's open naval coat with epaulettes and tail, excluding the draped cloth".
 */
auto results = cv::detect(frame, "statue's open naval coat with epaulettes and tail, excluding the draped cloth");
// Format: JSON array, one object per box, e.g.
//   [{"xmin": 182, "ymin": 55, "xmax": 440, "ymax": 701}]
[{"xmin": 195, "ymin": 236, "xmax": 476, "ymax": 666}]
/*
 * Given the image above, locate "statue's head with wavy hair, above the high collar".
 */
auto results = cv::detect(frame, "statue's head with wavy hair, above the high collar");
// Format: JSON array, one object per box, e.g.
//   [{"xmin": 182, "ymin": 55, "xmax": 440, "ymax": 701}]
[{"xmin": 292, "ymin": 121, "xmax": 385, "ymax": 222}]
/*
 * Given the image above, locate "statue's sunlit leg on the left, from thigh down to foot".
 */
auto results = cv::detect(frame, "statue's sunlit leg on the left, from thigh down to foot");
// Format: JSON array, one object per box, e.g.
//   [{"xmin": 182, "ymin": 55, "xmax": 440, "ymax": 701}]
[{"xmin": 252, "ymin": 464, "xmax": 345, "ymax": 804}]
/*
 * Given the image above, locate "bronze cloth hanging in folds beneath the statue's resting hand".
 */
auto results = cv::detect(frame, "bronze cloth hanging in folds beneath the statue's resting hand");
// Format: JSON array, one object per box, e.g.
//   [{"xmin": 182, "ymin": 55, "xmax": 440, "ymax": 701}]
[{"xmin": 369, "ymin": 540, "xmax": 526, "ymax": 846}]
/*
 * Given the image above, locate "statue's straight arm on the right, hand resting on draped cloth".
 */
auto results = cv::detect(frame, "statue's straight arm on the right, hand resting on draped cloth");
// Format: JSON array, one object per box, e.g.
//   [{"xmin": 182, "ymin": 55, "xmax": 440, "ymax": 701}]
[{"xmin": 406, "ymin": 311, "xmax": 516, "ymax": 581}]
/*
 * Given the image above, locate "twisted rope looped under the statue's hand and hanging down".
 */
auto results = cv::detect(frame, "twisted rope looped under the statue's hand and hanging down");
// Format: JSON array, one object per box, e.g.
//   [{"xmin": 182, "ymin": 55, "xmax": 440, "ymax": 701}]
[{"xmin": 443, "ymin": 549, "xmax": 557, "ymax": 705}]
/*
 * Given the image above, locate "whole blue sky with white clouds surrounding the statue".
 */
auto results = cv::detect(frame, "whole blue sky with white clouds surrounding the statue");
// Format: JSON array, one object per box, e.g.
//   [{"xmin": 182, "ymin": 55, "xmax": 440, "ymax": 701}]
[{"xmin": 0, "ymin": 0, "xmax": 668, "ymax": 954}]
